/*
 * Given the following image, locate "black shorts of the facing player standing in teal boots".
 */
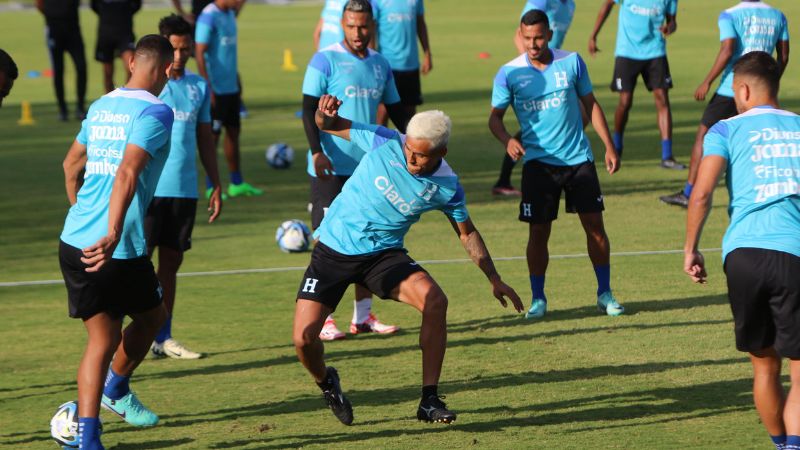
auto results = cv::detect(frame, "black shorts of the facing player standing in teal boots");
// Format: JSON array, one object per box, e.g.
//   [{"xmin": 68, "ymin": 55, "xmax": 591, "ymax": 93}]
[{"xmin": 519, "ymin": 160, "xmax": 605, "ymax": 223}]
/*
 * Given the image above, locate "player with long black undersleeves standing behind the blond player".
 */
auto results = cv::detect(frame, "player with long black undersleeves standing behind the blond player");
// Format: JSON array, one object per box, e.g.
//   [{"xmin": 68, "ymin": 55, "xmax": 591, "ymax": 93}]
[{"xmin": 303, "ymin": 0, "xmax": 408, "ymax": 341}]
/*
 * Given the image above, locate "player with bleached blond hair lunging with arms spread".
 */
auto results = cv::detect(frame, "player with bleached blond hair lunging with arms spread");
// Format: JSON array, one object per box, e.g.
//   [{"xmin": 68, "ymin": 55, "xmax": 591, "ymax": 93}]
[{"xmin": 293, "ymin": 94, "xmax": 523, "ymax": 425}]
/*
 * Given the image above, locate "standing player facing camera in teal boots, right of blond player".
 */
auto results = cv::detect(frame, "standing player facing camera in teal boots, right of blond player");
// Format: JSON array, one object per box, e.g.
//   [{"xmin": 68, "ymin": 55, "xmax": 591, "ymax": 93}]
[{"xmin": 489, "ymin": 10, "xmax": 624, "ymax": 319}]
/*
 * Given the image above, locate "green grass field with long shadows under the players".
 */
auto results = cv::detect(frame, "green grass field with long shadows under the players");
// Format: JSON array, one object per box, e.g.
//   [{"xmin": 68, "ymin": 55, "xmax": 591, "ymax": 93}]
[{"xmin": 0, "ymin": 0, "xmax": 800, "ymax": 449}]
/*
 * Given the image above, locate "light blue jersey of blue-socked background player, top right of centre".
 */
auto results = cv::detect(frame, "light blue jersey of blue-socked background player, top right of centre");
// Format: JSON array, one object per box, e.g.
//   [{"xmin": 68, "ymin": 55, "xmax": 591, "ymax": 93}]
[{"xmin": 614, "ymin": 0, "xmax": 678, "ymax": 61}]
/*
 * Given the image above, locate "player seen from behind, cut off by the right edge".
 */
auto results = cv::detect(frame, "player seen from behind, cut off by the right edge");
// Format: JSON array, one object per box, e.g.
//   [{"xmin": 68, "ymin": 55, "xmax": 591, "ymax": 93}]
[{"xmin": 683, "ymin": 51, "xmax": 800, "ymax": 450}]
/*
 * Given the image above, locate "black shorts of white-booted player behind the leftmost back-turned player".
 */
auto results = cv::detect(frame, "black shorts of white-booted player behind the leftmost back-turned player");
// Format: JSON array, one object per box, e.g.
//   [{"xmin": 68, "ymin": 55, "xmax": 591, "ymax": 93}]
[{"xmin": 144, "ymin": 197, "xmax": 197, "ymax": 252}]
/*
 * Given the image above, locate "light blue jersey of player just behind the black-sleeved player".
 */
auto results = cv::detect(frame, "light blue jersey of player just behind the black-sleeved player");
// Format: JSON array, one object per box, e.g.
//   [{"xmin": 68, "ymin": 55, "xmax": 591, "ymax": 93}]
[{"xmin": 372, "ymin": 0, "xmax": 425, "ymax": 71}]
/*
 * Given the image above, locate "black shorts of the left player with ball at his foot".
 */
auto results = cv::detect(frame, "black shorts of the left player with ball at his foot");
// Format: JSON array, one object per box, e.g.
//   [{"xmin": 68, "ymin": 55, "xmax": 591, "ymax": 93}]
[{"xmin": 58, "ymin": 241, "xmax": 161, "ymax": 319}]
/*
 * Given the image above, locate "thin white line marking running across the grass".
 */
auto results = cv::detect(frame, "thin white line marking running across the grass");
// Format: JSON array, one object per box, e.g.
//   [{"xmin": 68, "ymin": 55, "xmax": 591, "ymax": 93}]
[{"xmin": 0, "ymin": 248, "xmax": 722, "ymax": 287}]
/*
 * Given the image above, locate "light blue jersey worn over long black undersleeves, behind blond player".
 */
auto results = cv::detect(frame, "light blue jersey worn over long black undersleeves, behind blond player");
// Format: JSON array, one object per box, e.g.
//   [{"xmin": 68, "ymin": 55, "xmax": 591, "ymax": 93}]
[{"xmin": 303, "ymin": 42, "xmax": 400, "ymax": 176}]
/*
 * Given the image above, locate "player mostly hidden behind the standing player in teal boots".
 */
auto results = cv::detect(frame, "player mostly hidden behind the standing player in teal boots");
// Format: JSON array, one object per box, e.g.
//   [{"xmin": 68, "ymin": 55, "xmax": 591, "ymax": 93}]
[{"xmin": 492, "ymin": 0, "xmax": 575, "ymax": 196}]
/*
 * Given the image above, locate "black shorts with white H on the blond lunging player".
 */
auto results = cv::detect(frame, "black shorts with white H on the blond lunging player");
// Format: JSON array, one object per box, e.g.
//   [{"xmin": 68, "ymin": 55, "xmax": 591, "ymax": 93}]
[{"xmin": 297, "ymin": 242, "xmax": 425, "ymax": 311}]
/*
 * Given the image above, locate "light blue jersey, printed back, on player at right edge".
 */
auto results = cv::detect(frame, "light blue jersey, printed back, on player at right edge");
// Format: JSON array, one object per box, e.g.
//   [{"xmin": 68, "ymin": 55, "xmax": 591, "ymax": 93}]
[{"xmin": 703, "ymin": 106, "xmax": 800, "ymax": 260}]
